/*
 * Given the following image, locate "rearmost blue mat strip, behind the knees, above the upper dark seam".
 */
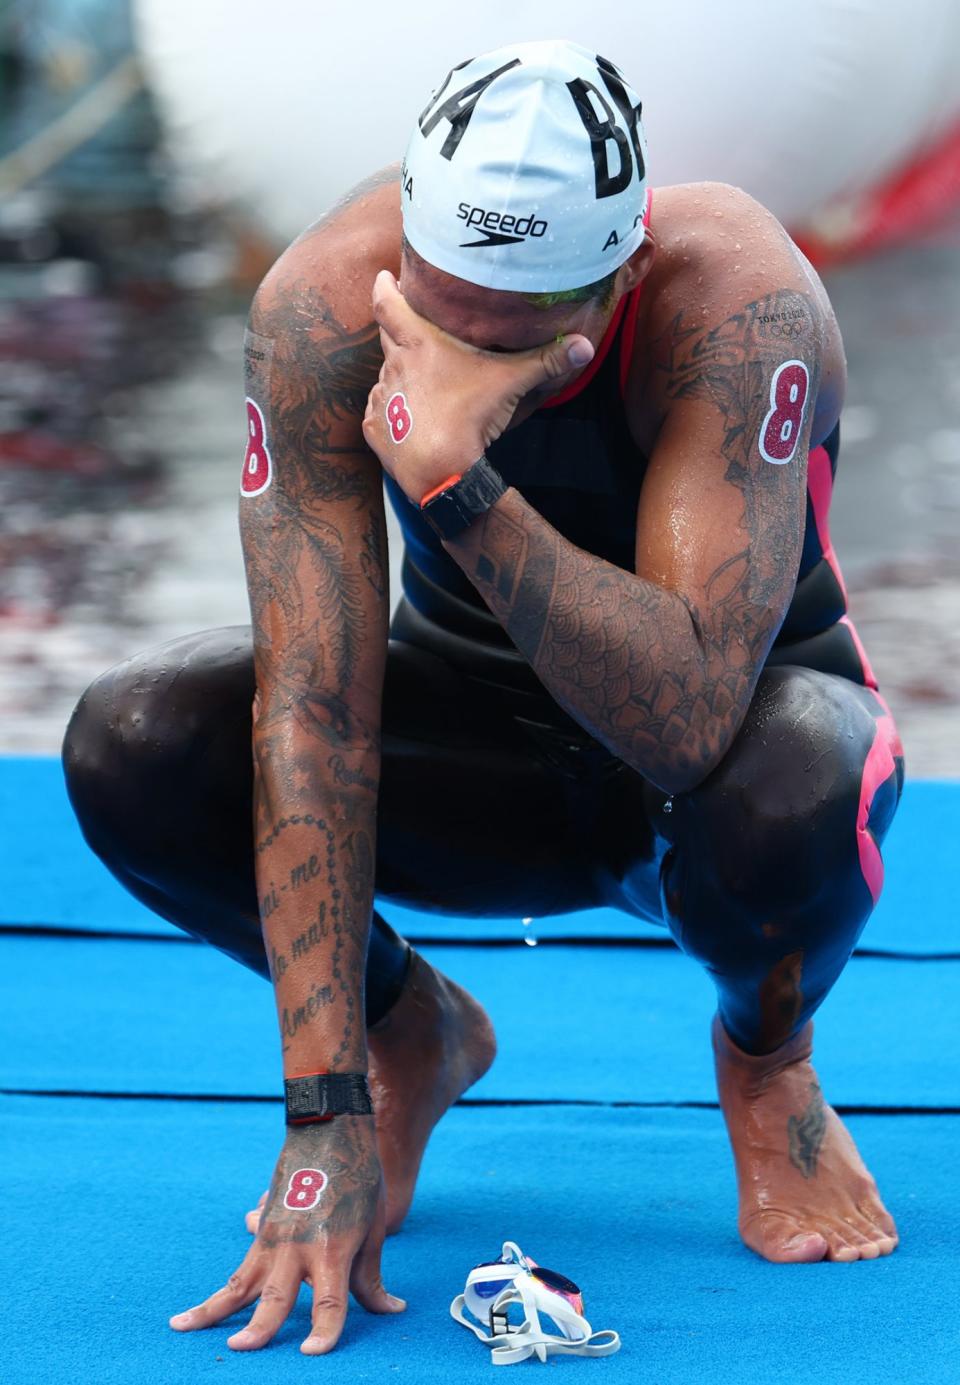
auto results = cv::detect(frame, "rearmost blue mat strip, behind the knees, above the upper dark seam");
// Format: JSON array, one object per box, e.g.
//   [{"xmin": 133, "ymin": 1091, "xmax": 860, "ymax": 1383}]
[{"xmin": 0, "ymin": 756, "xmax": 960, "ymax": 956}]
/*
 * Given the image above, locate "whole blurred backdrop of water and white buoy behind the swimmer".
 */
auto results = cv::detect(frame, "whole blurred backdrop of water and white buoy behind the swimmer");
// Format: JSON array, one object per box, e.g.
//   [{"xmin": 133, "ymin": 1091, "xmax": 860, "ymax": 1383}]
[{"xmin": 0, "ymin": 0, "xmax": 960, "ymax": 776}]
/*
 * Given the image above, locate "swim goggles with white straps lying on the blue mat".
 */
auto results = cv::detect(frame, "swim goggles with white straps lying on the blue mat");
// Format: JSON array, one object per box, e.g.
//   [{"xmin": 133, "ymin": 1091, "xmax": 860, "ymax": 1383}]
[{"xmin": 450, "ymin": 1241, "xmax": 621, "ymax": 1366}]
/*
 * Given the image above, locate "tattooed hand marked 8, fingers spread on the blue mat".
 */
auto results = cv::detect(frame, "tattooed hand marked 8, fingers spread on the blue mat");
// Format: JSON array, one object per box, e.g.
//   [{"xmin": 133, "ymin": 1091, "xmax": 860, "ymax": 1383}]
[{"xmin": 170, "ymin": 1115, "xmax": 406, "ymax": 1356}]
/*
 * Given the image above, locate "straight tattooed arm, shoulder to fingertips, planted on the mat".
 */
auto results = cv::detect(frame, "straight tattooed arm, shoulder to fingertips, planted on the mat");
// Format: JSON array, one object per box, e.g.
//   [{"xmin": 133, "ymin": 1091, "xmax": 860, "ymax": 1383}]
[{"xmin": 170, "ymin": 175, "xmax": 405, "ymax": 1355}]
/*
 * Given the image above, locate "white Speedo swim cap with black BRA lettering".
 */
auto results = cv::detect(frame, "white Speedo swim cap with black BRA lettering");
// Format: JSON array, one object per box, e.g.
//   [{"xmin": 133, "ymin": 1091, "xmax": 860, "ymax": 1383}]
[{"xmin": 400, "ymin": 39, "xmax": 647, "ymax": 294}]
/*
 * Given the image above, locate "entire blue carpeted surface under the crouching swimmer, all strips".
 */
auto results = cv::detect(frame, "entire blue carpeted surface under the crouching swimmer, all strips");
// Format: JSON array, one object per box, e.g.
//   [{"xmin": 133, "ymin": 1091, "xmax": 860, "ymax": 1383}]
[{"xmin": 0, "ymin": 759, "xmax": 960, "ymax": 1385}]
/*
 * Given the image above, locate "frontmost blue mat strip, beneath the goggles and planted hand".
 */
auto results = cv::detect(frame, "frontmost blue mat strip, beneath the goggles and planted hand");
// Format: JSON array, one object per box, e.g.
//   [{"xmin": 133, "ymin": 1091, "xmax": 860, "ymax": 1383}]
[{"xmin": 0, "ymin": 1098, "xmax": 960, "ymax": 1385}]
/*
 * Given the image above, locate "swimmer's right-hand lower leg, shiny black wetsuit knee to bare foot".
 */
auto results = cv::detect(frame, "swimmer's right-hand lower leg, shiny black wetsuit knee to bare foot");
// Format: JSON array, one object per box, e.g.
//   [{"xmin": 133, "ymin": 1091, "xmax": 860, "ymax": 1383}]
[{"xmin": 664, "ymin": 668, "xmax": 896, "ymax": 1262}]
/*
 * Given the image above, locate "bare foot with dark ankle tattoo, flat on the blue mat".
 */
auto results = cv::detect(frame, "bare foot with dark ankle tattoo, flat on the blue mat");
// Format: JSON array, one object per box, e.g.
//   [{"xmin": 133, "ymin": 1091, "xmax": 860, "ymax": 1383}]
[{"xmin": 713, "ymin": 1015, "xmax": 899, "ymax": 1263}]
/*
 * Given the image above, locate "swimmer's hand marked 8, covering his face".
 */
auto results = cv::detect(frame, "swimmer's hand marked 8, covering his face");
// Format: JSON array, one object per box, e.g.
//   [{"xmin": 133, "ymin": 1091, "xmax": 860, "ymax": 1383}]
[{"xmin": 363, "ymin": 270, "xmax": 593, "ymax": 506}]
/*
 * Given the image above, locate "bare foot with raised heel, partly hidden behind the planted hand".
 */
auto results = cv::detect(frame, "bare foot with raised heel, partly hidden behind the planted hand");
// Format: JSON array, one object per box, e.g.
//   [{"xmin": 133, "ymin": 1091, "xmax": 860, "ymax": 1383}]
[{"xmin": 247, "ymin": 953, "xmax": 496, "ymax": 1235}]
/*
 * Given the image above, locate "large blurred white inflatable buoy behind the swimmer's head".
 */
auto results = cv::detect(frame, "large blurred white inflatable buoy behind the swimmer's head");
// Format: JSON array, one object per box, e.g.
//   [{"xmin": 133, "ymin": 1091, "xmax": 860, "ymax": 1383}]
[{"xmin": 136, "ymin": 0, "xmax": 960, "ymax": 244}]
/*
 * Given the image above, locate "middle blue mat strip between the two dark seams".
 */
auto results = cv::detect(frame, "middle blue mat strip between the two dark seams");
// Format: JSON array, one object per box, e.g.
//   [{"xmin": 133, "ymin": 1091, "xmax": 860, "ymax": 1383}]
[{"xmin": 0, "ymin": 936, "xmax": 960, "ymax": 1108}]
